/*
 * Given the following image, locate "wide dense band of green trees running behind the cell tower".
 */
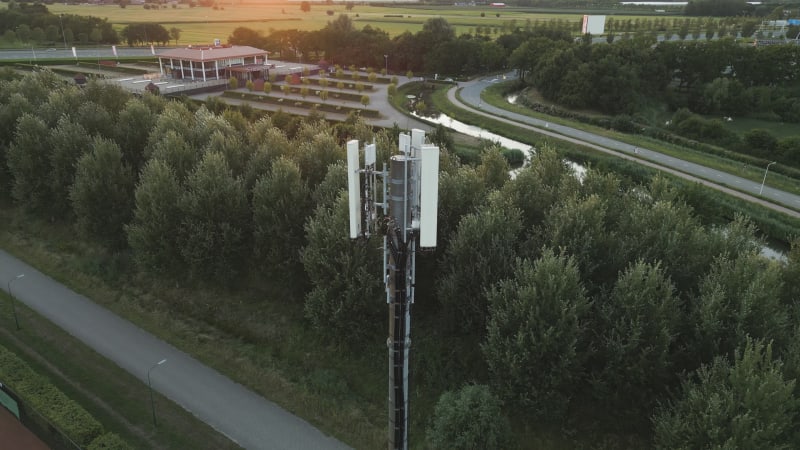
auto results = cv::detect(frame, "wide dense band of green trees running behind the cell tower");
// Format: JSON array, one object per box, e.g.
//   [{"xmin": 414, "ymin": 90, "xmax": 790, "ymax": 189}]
[{"xmin": 0, "ymin": 68, "xmax": 800, "ymax": 448}]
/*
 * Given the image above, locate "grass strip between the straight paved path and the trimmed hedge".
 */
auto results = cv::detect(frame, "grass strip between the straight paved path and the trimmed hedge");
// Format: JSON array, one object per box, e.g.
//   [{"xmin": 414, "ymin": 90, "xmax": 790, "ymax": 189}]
[{"xmin": 0, "ymin": 288, "xmax": 239, "ymax": 450}]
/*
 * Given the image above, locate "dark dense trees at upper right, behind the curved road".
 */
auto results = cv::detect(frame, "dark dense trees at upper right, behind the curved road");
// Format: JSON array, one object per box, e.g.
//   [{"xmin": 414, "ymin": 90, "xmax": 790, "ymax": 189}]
[{"xmin": 509, "ymin": 36, "xmax": 800, "ymax": 116}]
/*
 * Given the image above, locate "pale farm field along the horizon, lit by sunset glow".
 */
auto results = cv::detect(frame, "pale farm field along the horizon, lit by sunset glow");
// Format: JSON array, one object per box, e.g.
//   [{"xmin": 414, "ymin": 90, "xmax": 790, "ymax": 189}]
[{"xmin": 42, "ymin": 3, "xmax": 670, "ymax": 45}]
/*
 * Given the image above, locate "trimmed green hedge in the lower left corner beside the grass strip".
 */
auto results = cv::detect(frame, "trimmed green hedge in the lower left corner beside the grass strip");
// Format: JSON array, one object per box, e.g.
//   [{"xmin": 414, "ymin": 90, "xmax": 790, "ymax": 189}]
[{"xmin": 0, "ymin": 346, "xmax": 130, "ymax": 449}]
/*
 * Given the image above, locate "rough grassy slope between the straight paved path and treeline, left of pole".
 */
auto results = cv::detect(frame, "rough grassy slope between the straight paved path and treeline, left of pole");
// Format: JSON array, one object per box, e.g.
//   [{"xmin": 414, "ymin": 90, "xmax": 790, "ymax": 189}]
[{"xmin": 0, "ymin": 203, "xmax": 386, "ymax": 449}]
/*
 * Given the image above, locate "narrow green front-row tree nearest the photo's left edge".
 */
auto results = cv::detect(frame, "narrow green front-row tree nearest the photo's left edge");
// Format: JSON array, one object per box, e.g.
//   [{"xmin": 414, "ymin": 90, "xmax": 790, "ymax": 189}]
[{"xmin": 6, "ymin": 113, "xmax": 52, "ymax": 212}]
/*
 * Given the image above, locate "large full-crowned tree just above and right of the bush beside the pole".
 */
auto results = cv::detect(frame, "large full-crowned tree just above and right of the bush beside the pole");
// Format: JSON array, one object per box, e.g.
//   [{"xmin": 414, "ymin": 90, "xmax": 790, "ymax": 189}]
[{"xmin": 481, "ymin": 250, "xmax": 588, "ymax": 420}]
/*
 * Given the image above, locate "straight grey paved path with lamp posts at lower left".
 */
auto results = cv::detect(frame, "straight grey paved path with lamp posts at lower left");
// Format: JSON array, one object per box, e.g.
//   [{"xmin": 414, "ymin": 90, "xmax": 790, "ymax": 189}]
[{"xmin": 0, "ymin": 250, "xmax": 347, "ymax": 450}]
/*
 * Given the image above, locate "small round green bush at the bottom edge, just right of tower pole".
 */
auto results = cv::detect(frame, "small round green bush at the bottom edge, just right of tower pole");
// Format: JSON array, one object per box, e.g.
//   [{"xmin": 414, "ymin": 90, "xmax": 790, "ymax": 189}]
[{"xmin": 427, "ymin": 385, "xmax": 512, "ymax": 450}]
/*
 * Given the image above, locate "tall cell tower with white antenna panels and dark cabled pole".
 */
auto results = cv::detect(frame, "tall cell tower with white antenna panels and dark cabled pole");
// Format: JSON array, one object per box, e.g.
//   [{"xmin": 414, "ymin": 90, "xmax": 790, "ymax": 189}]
[{"xmin": 347, "ymin": 129, "xmax": 439, "ymax": 450}]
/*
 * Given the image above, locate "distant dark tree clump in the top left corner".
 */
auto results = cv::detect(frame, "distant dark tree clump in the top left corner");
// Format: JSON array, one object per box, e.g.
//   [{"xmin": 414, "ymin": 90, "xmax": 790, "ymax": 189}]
[{"xmin": 0, "ymin": 0, "xmax": 119, "ymax": 45}]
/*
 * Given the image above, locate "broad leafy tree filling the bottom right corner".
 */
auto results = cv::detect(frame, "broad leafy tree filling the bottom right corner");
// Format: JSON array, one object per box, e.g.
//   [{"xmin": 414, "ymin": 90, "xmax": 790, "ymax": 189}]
[{"xmin": 653, "ymin": 338, "xmax": 800, "ymax": 449}]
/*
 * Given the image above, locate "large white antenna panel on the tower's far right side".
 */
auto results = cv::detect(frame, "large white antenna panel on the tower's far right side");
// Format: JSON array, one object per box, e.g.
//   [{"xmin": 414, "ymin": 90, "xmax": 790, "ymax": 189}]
[{"xmin": 419, "ymin": 145, "xmax": 439, "ymax": 247}]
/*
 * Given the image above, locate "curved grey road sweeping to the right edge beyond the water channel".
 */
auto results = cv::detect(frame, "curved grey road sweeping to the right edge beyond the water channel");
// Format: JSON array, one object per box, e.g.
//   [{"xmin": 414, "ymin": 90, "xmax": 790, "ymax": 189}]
[{"xmin": 454, "ymin": 72, "xmax": 800, "ymax": 217}]
